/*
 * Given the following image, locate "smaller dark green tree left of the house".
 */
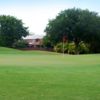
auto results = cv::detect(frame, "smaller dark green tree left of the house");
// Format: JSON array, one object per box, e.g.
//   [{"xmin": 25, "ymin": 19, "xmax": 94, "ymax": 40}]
[{"xmin": 0, "ymin": 15, "xmax": 29, "ymax": 47}]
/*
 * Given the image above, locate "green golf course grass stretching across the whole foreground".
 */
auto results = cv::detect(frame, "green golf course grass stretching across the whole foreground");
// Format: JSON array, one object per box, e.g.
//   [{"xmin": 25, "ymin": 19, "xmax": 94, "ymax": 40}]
[{"xmin": 0, "ymin": 48, "xmax": 100, "ymax": 100}]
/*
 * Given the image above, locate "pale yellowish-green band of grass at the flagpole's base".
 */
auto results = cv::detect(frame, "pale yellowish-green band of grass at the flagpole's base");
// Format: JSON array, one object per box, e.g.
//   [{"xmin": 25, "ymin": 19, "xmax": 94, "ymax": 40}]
[{"xmin": 0, "ymin": 54, "xmax": 100, "ymax": 67}]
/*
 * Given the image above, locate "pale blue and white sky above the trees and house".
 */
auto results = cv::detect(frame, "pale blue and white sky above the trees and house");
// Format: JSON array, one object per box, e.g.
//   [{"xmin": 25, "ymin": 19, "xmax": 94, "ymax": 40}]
[{"xmin": 0, "ymin": 0, "xmax": 100, "ymax": 35}]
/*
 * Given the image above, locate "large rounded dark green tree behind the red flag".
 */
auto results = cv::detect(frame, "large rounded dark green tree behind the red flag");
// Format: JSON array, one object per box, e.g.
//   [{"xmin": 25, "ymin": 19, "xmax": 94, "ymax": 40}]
[{"xmin": 45, "ymin": 8, "xmax": 100, "ymax": 52}]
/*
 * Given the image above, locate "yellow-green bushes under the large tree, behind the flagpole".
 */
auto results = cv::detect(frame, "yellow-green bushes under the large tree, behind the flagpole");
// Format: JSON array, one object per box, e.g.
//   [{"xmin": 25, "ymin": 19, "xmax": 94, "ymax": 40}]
[{"xmin": 54, "ymin": 41, "xmax": 89, "ymax": 54}]
